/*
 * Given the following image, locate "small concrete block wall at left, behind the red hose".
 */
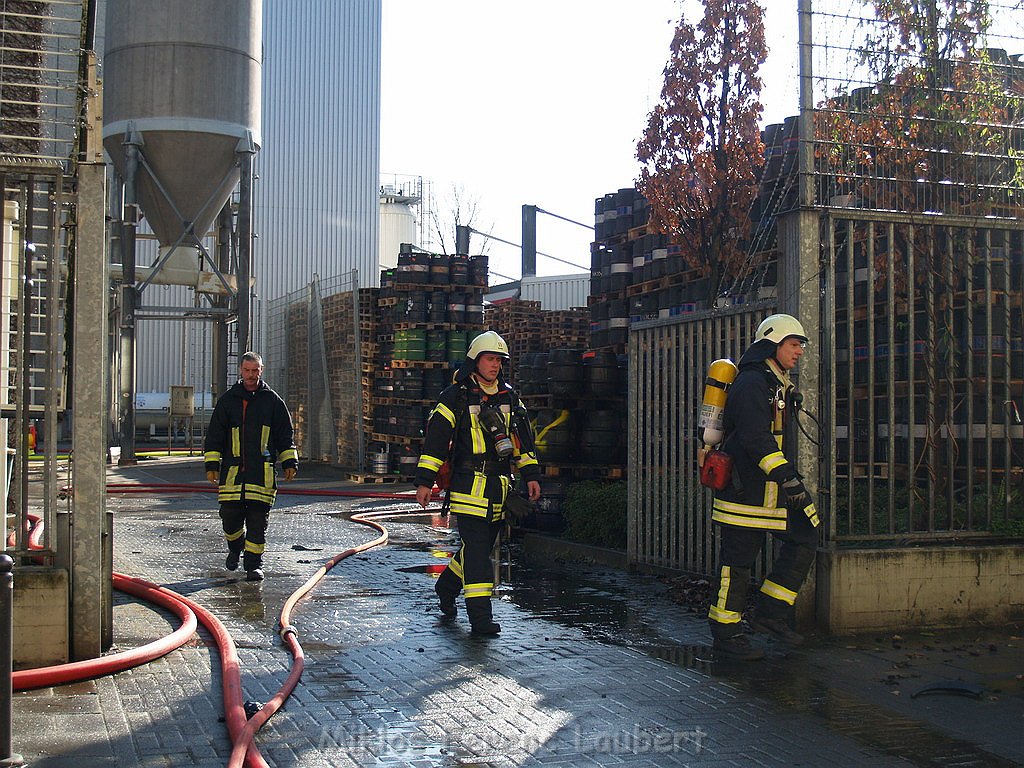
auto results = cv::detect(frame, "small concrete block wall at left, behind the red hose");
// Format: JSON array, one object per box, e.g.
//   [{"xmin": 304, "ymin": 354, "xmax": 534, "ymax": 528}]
[{"xmin": 13, "ymin": 565, "xmax": 71, "ymax": 670}]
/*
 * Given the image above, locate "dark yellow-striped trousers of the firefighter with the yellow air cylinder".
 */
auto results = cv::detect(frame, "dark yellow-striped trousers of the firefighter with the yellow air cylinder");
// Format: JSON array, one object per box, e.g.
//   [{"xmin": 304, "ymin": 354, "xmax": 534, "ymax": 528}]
[{"xmin": 708, "ymin": 510, "xmax": 818, "ymax": 638}]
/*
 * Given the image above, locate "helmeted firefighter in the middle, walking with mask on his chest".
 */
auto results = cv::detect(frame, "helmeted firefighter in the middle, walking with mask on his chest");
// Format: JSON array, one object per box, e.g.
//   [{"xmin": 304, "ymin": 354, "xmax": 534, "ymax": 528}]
[{"xmin": 415, "ymin": 331, "xmax": 541, "ymax": 635}]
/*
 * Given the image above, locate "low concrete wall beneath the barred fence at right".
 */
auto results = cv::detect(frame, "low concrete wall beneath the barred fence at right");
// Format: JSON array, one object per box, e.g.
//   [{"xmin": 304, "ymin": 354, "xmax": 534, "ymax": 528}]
[{"xmin": 816, "ymin": 546, "xmax": 1024, "ymax": 635}]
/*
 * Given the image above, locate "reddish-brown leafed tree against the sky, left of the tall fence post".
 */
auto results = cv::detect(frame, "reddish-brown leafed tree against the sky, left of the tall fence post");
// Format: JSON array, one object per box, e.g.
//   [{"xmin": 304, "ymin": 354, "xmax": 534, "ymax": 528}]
[{"xmin": 637, "ymin": 0, "xmax": 768, "ymax": 306}]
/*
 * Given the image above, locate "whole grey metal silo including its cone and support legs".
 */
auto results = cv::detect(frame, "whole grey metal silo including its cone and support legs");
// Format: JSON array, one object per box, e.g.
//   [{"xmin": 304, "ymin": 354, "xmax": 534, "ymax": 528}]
[{"xmin": 103, "ymin": 0, "xmax": 263, "ymax": 464}]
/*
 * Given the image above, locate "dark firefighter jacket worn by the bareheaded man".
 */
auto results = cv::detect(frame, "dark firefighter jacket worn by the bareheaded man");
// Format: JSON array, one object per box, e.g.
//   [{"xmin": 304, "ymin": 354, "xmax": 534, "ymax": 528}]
[{"xmin": 205, "ymin": 379, "xmax": 299, "ymax": 512}]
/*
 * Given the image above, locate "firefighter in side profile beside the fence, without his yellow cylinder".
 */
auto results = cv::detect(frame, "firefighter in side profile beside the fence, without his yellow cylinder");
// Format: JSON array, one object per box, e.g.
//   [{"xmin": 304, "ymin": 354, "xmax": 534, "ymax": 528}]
[{"xmin": 708, "ymin": 314, "xmax": 819, "ymax": 659}]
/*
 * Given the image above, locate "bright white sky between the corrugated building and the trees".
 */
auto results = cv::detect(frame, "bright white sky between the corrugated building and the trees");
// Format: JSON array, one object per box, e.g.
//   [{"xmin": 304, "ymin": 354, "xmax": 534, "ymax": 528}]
[{"xmin": 381, "ymin": 0, "xmax": 798, "ymax": 283}]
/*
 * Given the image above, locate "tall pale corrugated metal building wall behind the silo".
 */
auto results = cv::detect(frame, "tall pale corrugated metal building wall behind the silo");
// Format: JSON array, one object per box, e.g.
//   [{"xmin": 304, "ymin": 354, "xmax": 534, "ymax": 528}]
[{"xmin": 115, "ymin": 0, "xmax": 381, "ymax": 392}]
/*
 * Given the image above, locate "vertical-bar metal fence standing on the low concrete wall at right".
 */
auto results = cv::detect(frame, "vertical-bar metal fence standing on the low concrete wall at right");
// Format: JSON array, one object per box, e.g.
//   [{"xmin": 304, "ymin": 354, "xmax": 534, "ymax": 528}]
[{"xmin": 821, "ymin": 211, "xmax": 1024, "ymax": 544}]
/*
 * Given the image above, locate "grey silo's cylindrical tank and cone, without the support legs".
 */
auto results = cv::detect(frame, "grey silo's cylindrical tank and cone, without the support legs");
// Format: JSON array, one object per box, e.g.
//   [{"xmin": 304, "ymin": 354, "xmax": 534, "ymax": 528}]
[{"xmin": 103, "ymin": 0, "xmax": 262, "ymax": 252}]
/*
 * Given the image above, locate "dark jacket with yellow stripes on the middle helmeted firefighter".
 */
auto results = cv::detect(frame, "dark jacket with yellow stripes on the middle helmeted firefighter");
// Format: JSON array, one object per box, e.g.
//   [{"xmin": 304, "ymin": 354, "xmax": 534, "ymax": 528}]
[{"xmin": 414, "ymin": 369, "xmax": 541, "ymax": 517}]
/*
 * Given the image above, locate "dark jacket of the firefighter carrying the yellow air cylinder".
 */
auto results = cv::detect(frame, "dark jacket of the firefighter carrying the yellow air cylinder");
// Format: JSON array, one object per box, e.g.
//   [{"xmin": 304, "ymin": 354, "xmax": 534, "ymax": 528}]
[{"xmin": 712, "ymin": 340, "xmax": 815, "ymax": 530}]
